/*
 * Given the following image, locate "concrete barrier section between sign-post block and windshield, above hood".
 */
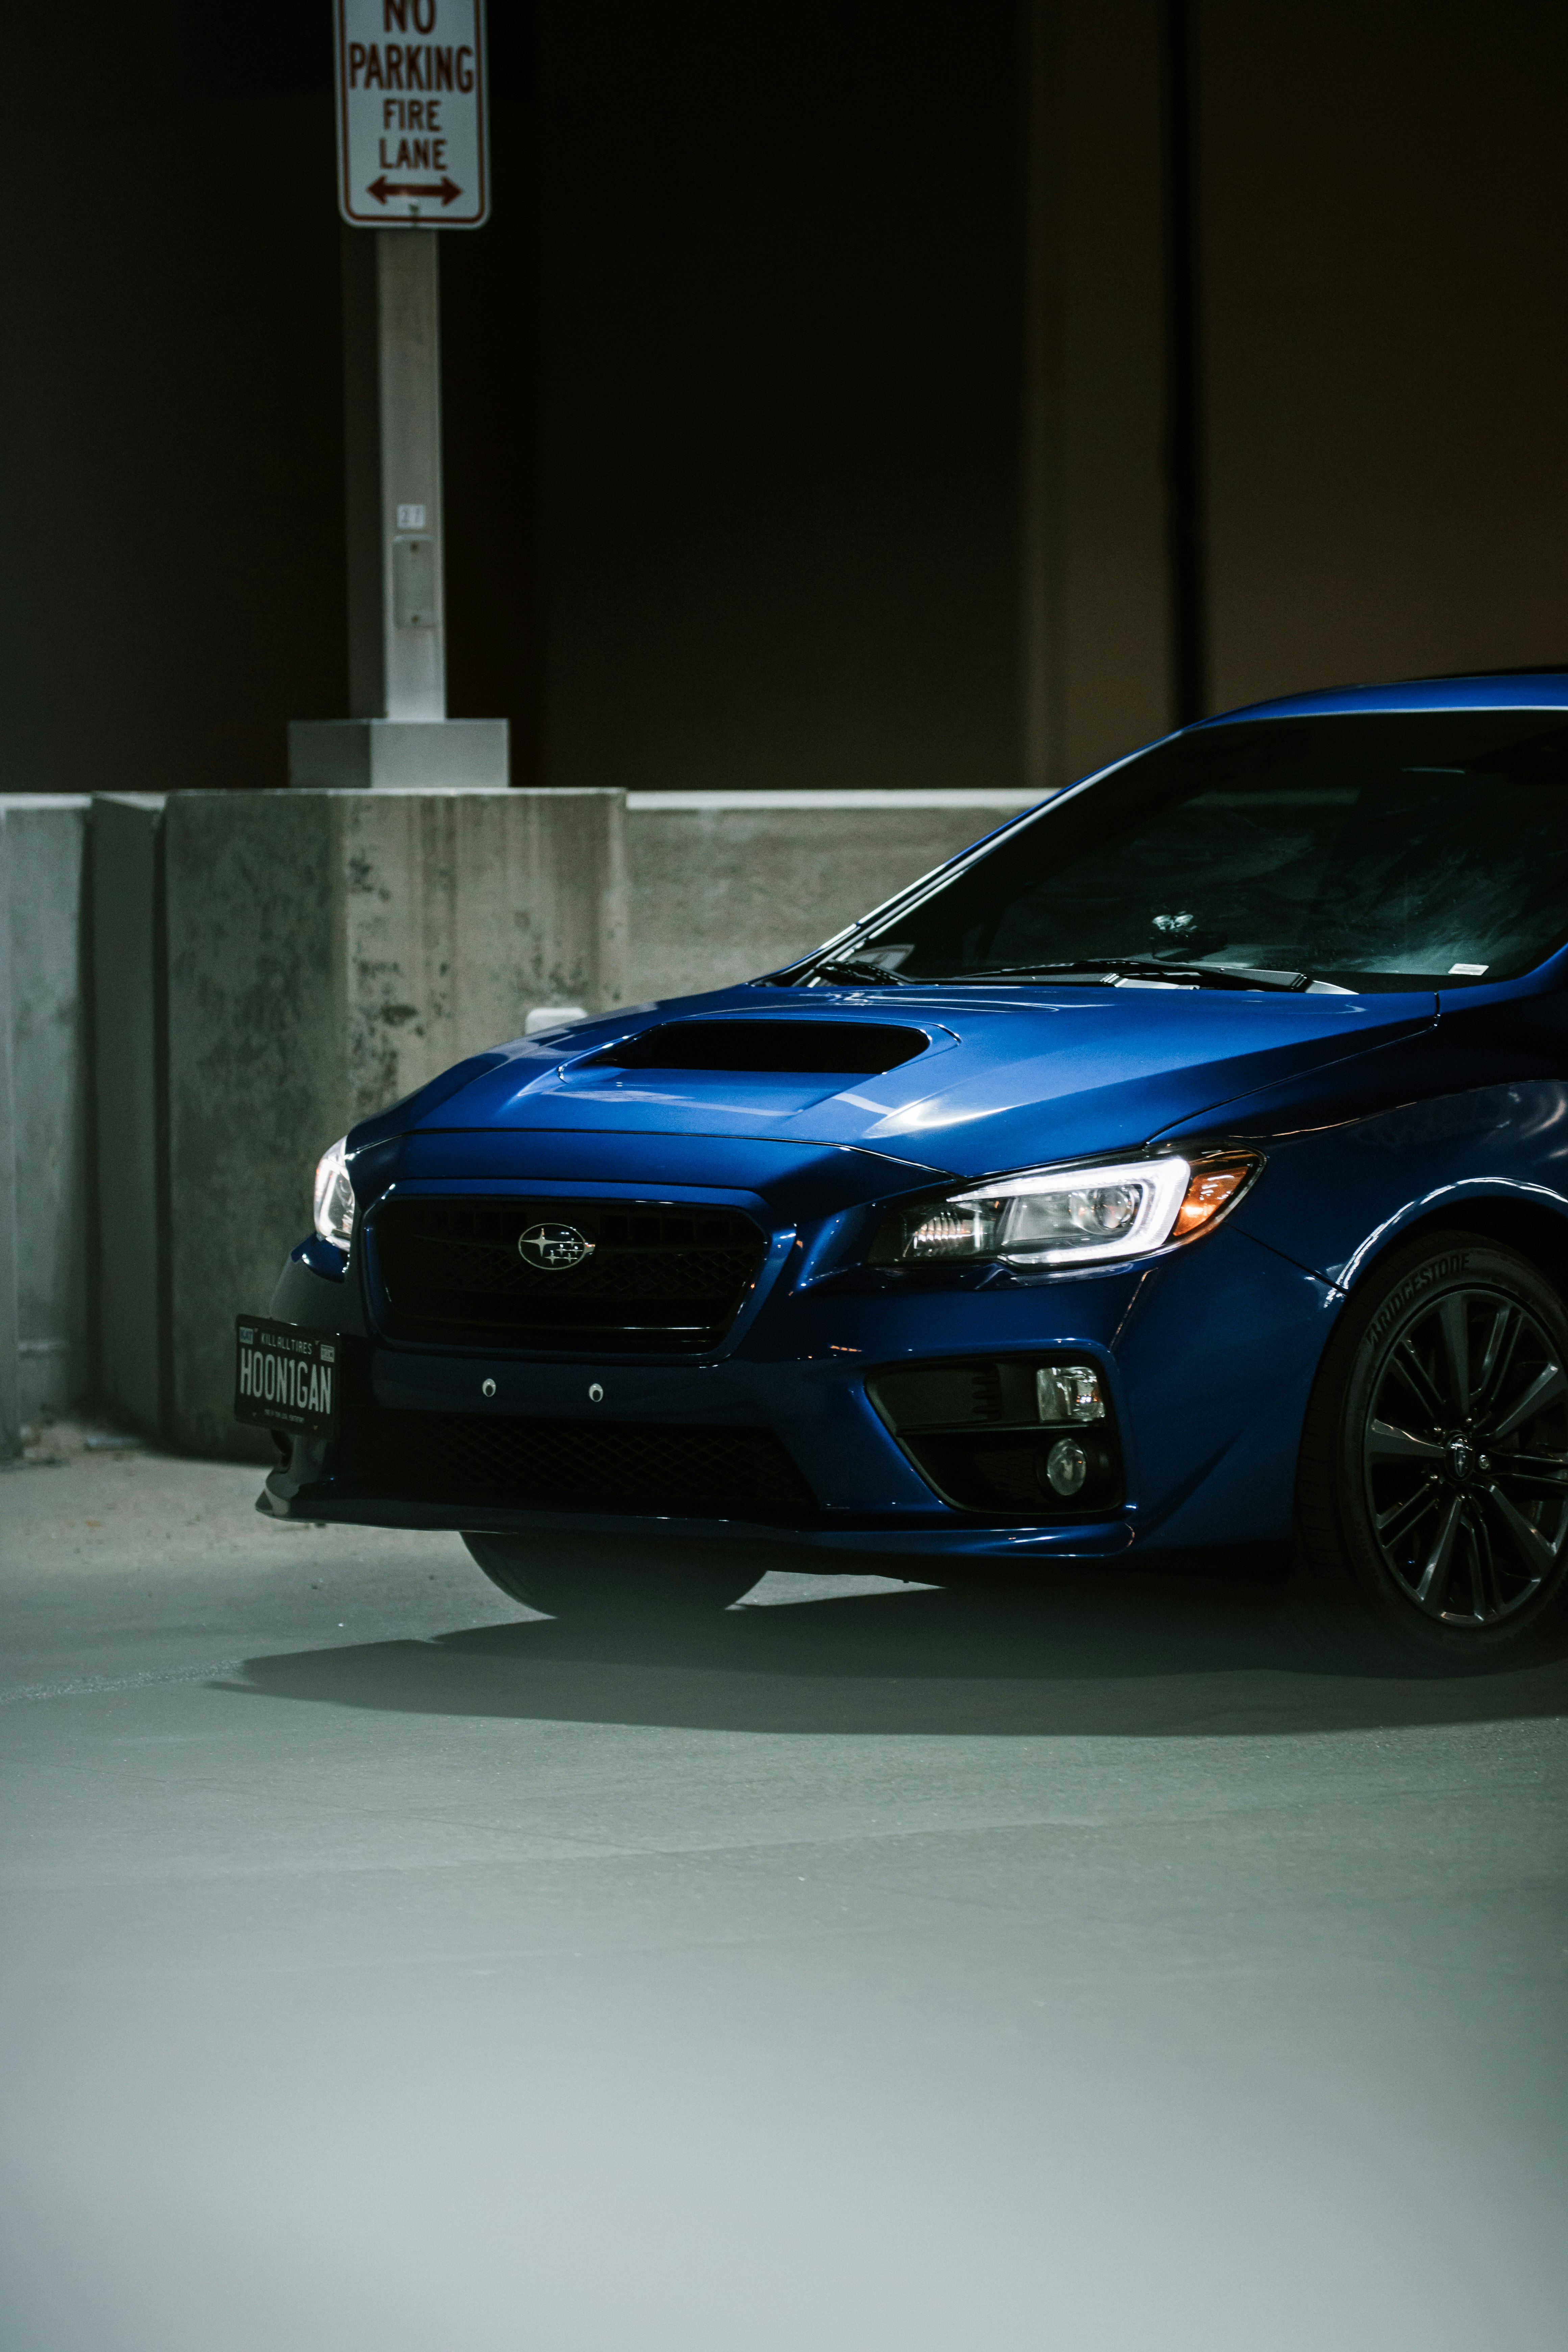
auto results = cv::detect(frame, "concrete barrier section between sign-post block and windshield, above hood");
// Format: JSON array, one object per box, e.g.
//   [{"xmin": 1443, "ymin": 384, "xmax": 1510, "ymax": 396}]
[{"xmin": 625, "ymin": 790, "xmax": 1030, "ymax": 1000}]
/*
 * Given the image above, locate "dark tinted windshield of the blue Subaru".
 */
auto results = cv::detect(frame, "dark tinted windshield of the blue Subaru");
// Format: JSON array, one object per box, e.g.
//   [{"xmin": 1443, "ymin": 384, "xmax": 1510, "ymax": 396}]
[{"xmin": 841, "ymin": 710, "xmax": 1568, "ymax": 990}]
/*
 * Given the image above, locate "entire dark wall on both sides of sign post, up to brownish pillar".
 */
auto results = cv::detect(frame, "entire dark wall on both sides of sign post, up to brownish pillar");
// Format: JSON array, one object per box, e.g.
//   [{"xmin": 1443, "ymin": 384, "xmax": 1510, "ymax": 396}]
[{"xmin": 0, "ymin": 0, "xmax": 1018, "ymax": 790}]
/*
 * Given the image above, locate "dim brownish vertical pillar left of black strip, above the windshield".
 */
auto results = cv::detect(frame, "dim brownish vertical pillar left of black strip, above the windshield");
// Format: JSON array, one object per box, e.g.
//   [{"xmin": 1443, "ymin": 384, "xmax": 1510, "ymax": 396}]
[{"xmin": 1023, "ymin": 0, "xmax": 1175, "ymax": 795}]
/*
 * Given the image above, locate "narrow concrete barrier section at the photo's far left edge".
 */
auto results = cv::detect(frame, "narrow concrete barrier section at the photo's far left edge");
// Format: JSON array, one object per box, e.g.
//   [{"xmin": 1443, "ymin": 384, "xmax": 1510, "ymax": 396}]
[{"xmin": 0, "ymin": 793, "xmax": 94, "ymax": 1456}]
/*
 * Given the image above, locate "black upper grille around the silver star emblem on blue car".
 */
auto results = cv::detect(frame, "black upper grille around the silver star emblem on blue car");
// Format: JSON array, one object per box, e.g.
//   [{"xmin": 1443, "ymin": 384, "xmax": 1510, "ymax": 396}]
[{"xmin": 371, "ymin": 1200, "xmax": 766, "ymax": 1355}]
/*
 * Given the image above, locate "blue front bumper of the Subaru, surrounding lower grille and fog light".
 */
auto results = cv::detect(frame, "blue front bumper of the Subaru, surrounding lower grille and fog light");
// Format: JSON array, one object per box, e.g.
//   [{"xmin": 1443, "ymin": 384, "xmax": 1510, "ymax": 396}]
[{"xmin": 261, "ymin": 1228, "xmax": 1338, "ymax": 1564}]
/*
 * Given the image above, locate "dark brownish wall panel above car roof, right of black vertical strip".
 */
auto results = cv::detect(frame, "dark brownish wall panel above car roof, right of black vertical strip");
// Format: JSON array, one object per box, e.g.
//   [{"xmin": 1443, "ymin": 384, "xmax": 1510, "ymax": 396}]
[{"xmin": 1199, "ymin": 0, "xmax": 1568, "ymax": 708}]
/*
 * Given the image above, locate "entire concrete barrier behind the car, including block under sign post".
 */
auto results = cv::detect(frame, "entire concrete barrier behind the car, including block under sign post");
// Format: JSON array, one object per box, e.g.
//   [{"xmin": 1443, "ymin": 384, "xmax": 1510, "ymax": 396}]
[{"xmin": 0, "ymin": 790, "xmax": 1044, "ymax": 1453}]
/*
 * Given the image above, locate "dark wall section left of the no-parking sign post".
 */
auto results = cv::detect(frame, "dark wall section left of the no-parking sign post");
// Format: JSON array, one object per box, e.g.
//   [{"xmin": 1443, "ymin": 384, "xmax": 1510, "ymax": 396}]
[{"xmin": 0, "ymin": 0, "xmax": 343, "ymax": 793}]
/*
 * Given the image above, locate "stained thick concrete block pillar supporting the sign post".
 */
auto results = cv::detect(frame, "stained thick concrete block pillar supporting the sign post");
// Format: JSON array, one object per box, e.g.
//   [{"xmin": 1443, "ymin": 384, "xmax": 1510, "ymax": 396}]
[{"xmin": 147, "ymin": 790, "xmax": 625, "ymax": 1456}]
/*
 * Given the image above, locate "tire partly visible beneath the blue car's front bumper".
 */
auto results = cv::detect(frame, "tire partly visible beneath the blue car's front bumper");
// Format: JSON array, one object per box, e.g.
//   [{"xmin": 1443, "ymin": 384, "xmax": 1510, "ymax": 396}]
[{"xmin": 463, "ymin": 1534, "xmax": 766, "ymax": 1625}]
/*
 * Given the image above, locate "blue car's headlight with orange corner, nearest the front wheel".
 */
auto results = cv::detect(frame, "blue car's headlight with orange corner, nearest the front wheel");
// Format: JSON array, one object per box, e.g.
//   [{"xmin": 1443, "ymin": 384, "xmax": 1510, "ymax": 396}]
[{"xmin": 872, "ymin": 1150, "xmax": 1263, "ymax": 1265}]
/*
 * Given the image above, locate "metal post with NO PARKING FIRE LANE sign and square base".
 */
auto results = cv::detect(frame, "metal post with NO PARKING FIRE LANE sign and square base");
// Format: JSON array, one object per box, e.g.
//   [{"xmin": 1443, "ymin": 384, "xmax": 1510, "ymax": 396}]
[{"xmin": 289, "ymin": 0, "xmax": 508, "ymax": 786}]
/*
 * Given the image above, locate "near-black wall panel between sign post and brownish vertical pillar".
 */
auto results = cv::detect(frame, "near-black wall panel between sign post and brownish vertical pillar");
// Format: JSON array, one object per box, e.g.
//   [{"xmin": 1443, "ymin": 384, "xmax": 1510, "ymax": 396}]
[{"xmin": 536, "ymin": 0, "xmax": 1020, "ymax": 788}]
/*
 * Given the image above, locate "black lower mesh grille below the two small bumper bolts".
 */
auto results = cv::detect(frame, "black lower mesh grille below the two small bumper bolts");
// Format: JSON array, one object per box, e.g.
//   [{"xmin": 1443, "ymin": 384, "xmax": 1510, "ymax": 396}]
[{"xmin": 343, "ymin": 1414, "xmax": 818, "ymax": 1526}]
